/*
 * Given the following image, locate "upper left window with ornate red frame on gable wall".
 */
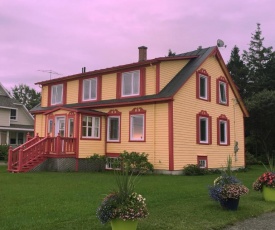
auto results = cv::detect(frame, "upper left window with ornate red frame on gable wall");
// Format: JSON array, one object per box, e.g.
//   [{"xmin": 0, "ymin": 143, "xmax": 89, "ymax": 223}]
[{"xmin": 196, "ymin": 69, "xmax": 211, "ymax": 101}]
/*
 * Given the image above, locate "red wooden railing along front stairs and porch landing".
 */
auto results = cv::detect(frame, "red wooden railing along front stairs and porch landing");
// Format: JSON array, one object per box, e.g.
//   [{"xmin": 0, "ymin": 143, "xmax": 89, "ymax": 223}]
[{"xmin": 8, "ymin": 135, "xmax": 76, "ymax": 172}]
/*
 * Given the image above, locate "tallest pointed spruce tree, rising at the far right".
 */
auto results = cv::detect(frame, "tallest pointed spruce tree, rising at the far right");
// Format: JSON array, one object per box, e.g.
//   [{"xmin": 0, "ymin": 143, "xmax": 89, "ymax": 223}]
[{"xmin": 243, "ymin": 23, "xmax": 274, "ymax": 95}]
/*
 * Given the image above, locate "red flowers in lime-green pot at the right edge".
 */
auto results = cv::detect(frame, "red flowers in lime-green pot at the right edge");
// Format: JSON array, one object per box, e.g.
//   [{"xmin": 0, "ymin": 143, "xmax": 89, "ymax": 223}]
[{"xmin": 253, "ymin": 157, "xmax": 275, "ymax": 201}]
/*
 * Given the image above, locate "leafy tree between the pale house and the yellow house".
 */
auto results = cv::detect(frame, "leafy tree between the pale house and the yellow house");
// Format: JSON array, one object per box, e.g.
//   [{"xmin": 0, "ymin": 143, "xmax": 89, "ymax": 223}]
[{"xmin": 11, "ymin": 84, "xmax": 41, "ymax": 110}]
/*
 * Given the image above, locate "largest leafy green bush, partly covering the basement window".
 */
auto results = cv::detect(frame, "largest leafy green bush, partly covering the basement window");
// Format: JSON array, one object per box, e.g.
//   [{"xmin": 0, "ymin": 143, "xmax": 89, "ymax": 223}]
[{"xmin": 119, "ymin": 151, "xmax": 154, "ymax": 174}]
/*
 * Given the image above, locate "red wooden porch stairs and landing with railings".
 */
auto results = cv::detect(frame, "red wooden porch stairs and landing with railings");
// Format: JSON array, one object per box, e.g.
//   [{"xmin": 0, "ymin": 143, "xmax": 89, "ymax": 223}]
[{"xmin": 8, "ymin": 134, "xmax": 77, "ymax": 172}]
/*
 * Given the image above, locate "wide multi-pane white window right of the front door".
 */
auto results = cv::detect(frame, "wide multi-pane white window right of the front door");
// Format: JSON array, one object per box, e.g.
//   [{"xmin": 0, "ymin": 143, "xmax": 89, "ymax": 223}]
[{"xmin": 82, "ymin": 116, "xmax": 100, "ymax": 138}]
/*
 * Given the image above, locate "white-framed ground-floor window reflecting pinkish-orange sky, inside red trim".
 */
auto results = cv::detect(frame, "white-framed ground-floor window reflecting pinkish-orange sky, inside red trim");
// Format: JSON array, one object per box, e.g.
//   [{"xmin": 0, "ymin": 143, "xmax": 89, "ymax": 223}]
[{"xmin": 130, "ymin": 114, "xmax": 144, "ymax": 141}]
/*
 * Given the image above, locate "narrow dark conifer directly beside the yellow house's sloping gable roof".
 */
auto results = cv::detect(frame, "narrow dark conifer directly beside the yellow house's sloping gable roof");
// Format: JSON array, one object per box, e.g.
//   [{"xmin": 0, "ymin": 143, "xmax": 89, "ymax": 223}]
[{"xmin": 227, "ymin": 46, "xmax": 248, "ymax": 99}]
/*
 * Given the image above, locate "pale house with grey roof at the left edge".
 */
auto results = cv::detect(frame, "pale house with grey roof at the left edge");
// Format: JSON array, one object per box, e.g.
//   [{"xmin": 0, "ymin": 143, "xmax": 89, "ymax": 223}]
[{"xmin": 0, "ymin": 83, "xmax": 34, "ymax": 147}]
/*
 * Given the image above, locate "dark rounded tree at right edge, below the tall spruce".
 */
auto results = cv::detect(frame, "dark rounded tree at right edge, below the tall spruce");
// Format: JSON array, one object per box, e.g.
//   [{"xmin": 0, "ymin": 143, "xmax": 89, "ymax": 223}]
[{"xmin": 245, "ymin": 90, "xmax": 275, "ymax": 160}]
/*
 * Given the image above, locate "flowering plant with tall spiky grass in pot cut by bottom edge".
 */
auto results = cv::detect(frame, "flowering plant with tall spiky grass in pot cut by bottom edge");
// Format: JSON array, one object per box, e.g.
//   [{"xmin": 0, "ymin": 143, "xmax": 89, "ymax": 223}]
[{"xmin": 96, "ymin": 170, "xmax": 149, "ymax": 230}]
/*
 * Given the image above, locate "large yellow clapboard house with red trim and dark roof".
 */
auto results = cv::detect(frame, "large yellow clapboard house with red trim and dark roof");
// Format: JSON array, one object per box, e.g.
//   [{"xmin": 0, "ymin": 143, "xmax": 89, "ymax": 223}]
[{"xmin": 10, "ymin": 47, "xmax": 248, "ymax": 173}]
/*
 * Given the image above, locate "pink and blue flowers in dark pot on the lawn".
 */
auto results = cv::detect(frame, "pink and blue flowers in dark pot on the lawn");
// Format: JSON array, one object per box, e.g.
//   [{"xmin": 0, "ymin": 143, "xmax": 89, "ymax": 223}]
[{"xmin": 209, "ymin": 156, "xmax": 249, "ymax": 211}]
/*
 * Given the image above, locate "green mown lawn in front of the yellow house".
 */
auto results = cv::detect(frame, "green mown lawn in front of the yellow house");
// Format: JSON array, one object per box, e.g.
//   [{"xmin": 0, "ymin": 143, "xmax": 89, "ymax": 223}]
[{"xmin": 0, "ymin": 166, "xmax": 275, "ymax": 230}]
